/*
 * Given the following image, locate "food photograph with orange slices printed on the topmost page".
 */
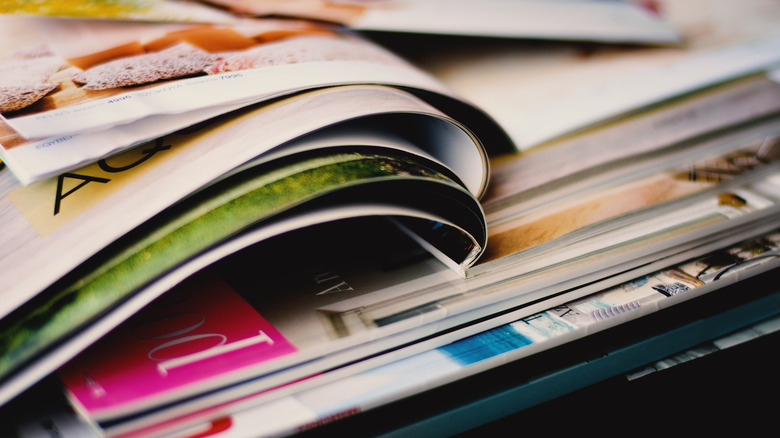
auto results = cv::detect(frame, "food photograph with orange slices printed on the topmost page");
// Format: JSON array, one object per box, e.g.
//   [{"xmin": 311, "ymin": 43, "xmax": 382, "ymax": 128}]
[{"xmin": 0, "ymin": 18, "xmax": 400, "ymax": 132}]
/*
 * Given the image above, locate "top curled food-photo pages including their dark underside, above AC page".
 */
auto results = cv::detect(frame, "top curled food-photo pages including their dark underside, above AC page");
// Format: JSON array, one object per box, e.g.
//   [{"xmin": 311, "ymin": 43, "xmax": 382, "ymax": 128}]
[{"xmin": 0, "ymin": 17, "xmax": 512, "ymax": 184}]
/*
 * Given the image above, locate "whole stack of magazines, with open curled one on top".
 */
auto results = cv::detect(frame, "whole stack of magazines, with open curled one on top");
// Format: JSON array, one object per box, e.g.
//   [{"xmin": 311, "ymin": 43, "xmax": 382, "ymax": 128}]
[{"xmin": 0, "ymin": 0, "xmax": 780, "ymax": 438}]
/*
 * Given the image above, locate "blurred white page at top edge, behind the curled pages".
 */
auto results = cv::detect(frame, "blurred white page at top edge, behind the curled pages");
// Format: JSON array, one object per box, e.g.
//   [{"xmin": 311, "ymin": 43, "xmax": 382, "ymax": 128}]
[{"xmin": 348, "ymin": 0, "xmax": 679, "ymax": 44}]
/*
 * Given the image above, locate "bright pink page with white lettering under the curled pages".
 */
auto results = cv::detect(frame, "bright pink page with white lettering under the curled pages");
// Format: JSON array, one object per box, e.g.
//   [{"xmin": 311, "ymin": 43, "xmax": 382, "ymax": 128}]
[{"xmin": 59, "ymin": 272, "xmax": 297, "ymax": 417}]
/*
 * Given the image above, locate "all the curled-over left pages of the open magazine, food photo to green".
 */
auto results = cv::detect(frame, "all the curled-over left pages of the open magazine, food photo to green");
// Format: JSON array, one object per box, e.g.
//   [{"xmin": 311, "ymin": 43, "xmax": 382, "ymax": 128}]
[{"xmin": 0, "ymin": 19, "xmax": 511, "ymax": 408}]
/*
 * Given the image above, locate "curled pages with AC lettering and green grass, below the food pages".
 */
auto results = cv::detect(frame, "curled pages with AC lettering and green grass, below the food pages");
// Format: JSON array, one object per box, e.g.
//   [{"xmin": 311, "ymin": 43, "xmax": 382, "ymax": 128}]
[{"xmin": 0, "ymin": 82, "xmax": 488, "ymax": 408}]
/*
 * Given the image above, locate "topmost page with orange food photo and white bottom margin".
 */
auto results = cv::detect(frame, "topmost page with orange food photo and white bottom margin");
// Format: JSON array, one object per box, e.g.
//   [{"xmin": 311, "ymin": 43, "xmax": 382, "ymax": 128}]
[{"xmin": 0, "ymin": 16, "xmax": 445, "ymax": 140}]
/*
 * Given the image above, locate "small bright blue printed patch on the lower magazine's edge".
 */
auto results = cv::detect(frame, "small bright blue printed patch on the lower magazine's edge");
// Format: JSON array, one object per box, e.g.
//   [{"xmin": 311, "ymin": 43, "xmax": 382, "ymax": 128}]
[{"xmin": 439, "ymin": 324, "xmax": 534, "ymax": 365}]
